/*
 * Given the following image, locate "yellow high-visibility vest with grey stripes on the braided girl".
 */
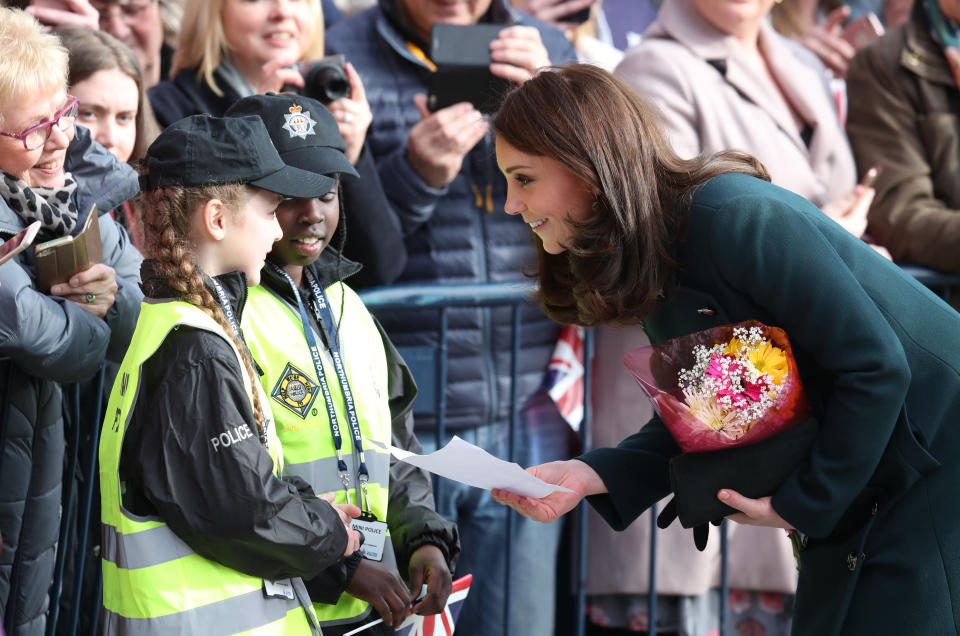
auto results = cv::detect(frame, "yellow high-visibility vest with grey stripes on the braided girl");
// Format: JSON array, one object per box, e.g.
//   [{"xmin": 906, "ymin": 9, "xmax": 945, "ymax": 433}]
[{"xmin": 100, "ymin": 301, "xmax": 317, "ymax": 636}]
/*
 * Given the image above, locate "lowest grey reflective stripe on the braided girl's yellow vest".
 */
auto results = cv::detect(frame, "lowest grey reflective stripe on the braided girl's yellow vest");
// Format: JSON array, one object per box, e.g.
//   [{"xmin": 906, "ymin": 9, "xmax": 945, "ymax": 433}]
[{"xmin": 103, "ymin": 589, "xmax": 312, "ymax": 636}]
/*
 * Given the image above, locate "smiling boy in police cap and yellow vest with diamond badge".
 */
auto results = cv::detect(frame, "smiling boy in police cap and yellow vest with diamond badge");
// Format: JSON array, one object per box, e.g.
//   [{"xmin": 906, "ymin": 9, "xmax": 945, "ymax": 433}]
[{"xmin": 227, "ymin": 94, "xmax": 460, "ymax": 635}]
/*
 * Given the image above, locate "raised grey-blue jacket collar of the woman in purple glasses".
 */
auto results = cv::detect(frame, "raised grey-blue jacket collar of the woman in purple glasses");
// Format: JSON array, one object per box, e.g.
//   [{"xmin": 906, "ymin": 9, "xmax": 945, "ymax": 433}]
[{"xmin": 0, "ymin": 126, "xmax": 140, "ymax": 234}]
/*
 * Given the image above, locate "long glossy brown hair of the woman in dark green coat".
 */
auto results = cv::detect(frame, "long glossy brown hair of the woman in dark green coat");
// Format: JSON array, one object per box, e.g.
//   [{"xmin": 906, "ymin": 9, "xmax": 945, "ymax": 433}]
[{"xmin": 493, "ymin": 64, "xmax": 769, "ymax": 326}]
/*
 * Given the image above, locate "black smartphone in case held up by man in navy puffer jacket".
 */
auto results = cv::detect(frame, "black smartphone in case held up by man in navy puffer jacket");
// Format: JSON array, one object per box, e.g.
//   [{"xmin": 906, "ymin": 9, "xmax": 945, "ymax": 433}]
[{"xmin": 427, "ymin": 24, "xmax": 510, "ymax": 113}]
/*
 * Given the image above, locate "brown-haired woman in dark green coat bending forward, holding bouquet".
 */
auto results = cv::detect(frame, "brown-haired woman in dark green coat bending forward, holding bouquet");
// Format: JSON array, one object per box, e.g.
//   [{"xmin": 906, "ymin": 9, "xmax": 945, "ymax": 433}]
[{"xmin": 494, "ymin": 65, "xmax": 960, "ymax": 635}]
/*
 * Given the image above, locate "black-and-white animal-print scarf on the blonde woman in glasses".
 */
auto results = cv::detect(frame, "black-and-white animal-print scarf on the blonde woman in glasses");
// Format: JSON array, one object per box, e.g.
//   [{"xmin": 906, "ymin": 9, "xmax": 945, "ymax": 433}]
[{"xmin": 0, "ymin": 172, "xmax": 77, "ymax": 238}]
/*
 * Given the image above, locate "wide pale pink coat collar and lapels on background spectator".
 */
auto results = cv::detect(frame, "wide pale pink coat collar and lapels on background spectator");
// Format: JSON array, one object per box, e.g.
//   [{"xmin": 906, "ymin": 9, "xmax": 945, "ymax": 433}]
[{"xmin": 644, "ymin": 0, "xmax": 824, "ymax": 154}]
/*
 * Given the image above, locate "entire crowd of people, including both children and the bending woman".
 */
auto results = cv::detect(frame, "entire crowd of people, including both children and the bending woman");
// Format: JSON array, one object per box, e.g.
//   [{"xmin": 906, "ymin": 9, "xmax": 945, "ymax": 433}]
[{"xmin": 0, "ymin": 0, "xmax": 960, "ymax": 636}]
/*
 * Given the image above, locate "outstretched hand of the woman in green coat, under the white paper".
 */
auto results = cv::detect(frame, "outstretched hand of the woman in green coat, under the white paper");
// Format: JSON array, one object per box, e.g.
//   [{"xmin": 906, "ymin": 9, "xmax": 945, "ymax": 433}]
[{"xmin": 492, "ymin": 459, "xmax": 607, "ymax": 523}]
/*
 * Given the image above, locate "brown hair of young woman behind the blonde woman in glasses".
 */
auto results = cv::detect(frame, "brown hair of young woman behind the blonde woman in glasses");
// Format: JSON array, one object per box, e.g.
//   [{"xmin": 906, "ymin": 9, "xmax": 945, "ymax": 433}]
[{"xmin": 53, "ymin": 26, "xmax": 160, "ymax": 166}]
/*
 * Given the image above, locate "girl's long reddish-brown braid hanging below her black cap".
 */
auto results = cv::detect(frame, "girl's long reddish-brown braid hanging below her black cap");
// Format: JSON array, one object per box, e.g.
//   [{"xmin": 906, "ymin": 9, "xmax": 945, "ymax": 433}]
[{"xmin": 141, "ymin": 180, "xmax": 266, "ymax": 443}]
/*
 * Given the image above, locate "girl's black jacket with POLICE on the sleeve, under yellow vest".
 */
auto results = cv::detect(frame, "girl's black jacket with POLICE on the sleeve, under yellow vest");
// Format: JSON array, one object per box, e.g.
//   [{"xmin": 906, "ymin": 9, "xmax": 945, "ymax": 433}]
[{"xmin": 119, "ymin": 260, "xmax": 347, "ymax": 579}]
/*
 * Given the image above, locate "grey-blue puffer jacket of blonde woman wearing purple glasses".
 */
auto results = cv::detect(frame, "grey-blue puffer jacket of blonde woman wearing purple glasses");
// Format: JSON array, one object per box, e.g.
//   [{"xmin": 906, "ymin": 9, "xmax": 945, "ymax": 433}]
[{"xmin": 0, "ymin": 126, "xmax": 143, "ymax": 636}]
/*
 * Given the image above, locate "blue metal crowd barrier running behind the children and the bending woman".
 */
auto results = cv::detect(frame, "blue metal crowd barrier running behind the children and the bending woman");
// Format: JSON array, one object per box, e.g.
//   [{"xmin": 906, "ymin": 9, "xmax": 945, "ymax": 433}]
[{"xmin": 0, "ymin": 266, "xmax": 960, "ymax": 636}]
